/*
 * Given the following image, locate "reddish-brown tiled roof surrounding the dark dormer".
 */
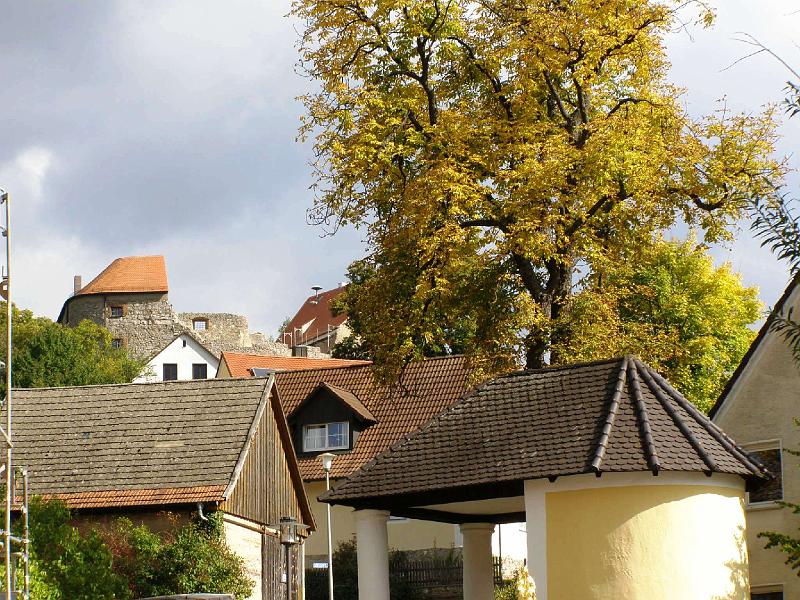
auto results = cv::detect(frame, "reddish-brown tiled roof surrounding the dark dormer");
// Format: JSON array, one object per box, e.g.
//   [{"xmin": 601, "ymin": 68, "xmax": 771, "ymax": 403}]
[{"xmin": 275, "ymin": 356, "xmax": 476, "ymax": 481}]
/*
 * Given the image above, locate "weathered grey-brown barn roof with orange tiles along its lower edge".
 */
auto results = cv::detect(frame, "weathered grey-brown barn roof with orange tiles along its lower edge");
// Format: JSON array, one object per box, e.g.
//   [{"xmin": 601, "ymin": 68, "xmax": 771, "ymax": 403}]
[{"xmin": 13, "ymin": 379, "xmax": 268, "ymax": 506}]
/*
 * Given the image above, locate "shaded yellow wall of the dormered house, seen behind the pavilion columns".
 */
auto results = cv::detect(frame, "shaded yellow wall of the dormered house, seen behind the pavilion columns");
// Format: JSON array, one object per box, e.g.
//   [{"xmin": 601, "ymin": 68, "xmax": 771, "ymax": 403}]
[{"xmin": 305, "ymin": 481, "xmax": 456, "ymax": 557}]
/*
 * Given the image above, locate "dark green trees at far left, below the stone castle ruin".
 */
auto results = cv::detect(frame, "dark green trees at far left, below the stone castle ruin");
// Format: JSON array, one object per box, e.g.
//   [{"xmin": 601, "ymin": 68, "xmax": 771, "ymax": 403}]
[{"xmin": 0, "ymin": 303, "xmax": 144, "ymax": 388}]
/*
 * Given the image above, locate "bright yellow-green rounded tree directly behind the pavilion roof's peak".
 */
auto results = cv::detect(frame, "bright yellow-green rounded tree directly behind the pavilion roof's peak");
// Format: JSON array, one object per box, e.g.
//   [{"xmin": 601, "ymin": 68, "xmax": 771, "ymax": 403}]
[{"xmin": 558, "ymin": 236, "xmax": 762, "ymax": 411}]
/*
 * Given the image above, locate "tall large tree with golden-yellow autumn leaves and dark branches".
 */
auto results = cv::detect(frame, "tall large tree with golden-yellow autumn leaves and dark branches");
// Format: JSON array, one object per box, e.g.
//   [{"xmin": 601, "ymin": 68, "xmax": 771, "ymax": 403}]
[{"xmin": 293, "ymin": 0, "xmax": 783, "ymax": 371}]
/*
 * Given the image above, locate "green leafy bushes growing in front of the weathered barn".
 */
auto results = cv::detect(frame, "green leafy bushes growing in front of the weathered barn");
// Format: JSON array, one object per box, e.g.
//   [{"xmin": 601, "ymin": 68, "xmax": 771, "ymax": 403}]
[{"xmin": 0, "ymin": 497, "xmax": 253, "ymax": 600}]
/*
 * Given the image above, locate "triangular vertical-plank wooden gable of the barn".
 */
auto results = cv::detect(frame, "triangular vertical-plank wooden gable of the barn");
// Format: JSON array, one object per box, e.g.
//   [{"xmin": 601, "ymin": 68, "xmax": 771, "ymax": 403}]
[{"xmin": 222, "ymin": 390, "xmax": 304, "ymax": 525}]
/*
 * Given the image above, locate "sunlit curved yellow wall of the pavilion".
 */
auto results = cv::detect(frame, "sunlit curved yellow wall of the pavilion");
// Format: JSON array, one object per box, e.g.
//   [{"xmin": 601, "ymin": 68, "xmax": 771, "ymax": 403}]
[{"xmin": 545, "ymin": 485, "xmax": 749, "ymax": 600}]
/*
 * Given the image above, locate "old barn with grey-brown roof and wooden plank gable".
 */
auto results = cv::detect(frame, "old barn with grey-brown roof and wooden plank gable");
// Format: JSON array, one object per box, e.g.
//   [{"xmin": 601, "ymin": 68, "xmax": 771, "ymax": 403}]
[{"xmin": 14, "ymin": 378, "xmax": 314, "ymax": 600}]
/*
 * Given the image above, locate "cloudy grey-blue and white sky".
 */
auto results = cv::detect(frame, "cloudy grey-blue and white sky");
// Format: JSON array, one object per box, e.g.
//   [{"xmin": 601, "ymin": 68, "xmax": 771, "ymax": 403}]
[{"xmin": 0, "ymin": 0, "xmax": 800, "ymax": 334}]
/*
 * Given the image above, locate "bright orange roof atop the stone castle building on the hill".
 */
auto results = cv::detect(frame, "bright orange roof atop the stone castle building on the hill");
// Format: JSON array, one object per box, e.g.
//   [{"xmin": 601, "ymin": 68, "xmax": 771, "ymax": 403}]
[{"xmin": 75, "ymin": 256, "xmax": 169, "ymax": 296}]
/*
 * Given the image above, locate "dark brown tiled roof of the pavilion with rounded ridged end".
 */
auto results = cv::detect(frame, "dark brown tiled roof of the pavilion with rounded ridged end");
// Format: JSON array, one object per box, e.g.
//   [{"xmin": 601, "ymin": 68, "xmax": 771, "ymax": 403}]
[{"xmin": 326, "ymin": 357, "xmax": 767, "ymax": 504}]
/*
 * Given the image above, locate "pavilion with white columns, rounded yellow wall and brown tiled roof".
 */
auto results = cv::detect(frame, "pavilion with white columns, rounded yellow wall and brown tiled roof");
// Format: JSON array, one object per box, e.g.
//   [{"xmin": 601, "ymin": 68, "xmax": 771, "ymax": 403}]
[{"xmin": 321, "ymin": 356, "xmax": 769, "ymax": 600}]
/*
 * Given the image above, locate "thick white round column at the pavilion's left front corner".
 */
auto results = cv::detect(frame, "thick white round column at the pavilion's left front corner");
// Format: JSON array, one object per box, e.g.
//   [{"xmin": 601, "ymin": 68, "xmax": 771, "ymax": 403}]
[{"xmin": 355, "ymin": 510, "xmax": 389, "ymax": 600}]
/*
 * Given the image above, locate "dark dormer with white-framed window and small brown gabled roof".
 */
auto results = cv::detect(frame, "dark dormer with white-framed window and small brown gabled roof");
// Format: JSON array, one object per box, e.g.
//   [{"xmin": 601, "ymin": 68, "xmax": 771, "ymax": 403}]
[{"xmin": 288, "ymin": 381, "xmax": 378, "ymax": 456}]
